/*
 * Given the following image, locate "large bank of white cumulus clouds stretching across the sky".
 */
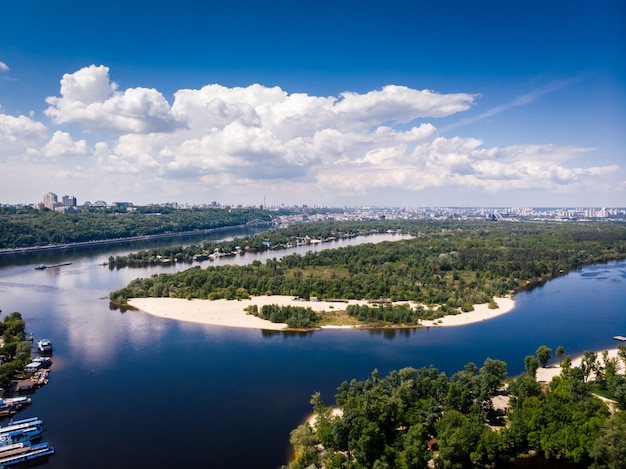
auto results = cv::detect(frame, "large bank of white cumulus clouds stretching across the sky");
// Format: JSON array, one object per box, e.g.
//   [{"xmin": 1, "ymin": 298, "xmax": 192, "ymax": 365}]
[{"xmin": 0, "ymin": 65, "xmax": 623, "ymax": 203}]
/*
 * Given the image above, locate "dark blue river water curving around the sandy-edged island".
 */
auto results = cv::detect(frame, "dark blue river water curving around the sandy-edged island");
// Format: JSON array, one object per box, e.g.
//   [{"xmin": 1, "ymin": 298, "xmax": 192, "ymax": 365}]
[{"xmin": 0, "ymin": 236, "xmax": 626, "ymax": 469}]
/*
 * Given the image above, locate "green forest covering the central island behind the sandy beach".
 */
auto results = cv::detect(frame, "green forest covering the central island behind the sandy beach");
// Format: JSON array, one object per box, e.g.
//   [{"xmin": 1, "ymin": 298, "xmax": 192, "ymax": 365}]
[{"xmin": 109, "ymin": 221, "xmax": 626, "ymax": 325}]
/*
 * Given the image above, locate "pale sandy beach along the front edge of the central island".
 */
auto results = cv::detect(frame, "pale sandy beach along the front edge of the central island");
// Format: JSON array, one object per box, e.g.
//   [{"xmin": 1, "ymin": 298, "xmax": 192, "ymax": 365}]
[{"xmin": 128, "ymin": 295, "xmax": 515, "ymax": 330}]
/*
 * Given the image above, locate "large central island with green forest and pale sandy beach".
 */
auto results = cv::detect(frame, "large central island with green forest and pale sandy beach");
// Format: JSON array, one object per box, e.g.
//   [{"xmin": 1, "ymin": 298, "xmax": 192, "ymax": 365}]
[{"xmin": 109, "ymin": 221, "xmax": 626, "ymax": 330}]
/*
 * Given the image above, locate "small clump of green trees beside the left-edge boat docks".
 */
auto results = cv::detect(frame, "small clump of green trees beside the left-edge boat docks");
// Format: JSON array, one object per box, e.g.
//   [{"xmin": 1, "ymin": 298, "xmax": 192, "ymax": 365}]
[{"xmin": 0, "ymin": 312, "xmax": 30, "ymax": 386}]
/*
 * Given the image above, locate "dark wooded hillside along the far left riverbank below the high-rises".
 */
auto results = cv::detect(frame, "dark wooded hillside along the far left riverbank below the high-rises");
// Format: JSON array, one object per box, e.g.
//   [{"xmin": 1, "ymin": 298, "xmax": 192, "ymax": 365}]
[{"xmin": 0, "ymin": 207, "xmax": 271, "ymax": 249}]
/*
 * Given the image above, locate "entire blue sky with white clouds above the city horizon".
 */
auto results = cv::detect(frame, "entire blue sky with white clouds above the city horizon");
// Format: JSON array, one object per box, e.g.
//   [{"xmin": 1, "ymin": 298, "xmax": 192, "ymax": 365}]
[{"xmin": 0, "ymin": 0, "xmax": 626, "ymax": 207}]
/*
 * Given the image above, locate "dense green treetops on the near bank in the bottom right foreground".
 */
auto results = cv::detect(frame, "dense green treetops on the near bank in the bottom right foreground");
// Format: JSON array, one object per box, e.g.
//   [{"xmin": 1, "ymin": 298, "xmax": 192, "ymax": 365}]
[{"xmin": 284, "ymin": 345, "xmax": 626, "ymax": 469}]
